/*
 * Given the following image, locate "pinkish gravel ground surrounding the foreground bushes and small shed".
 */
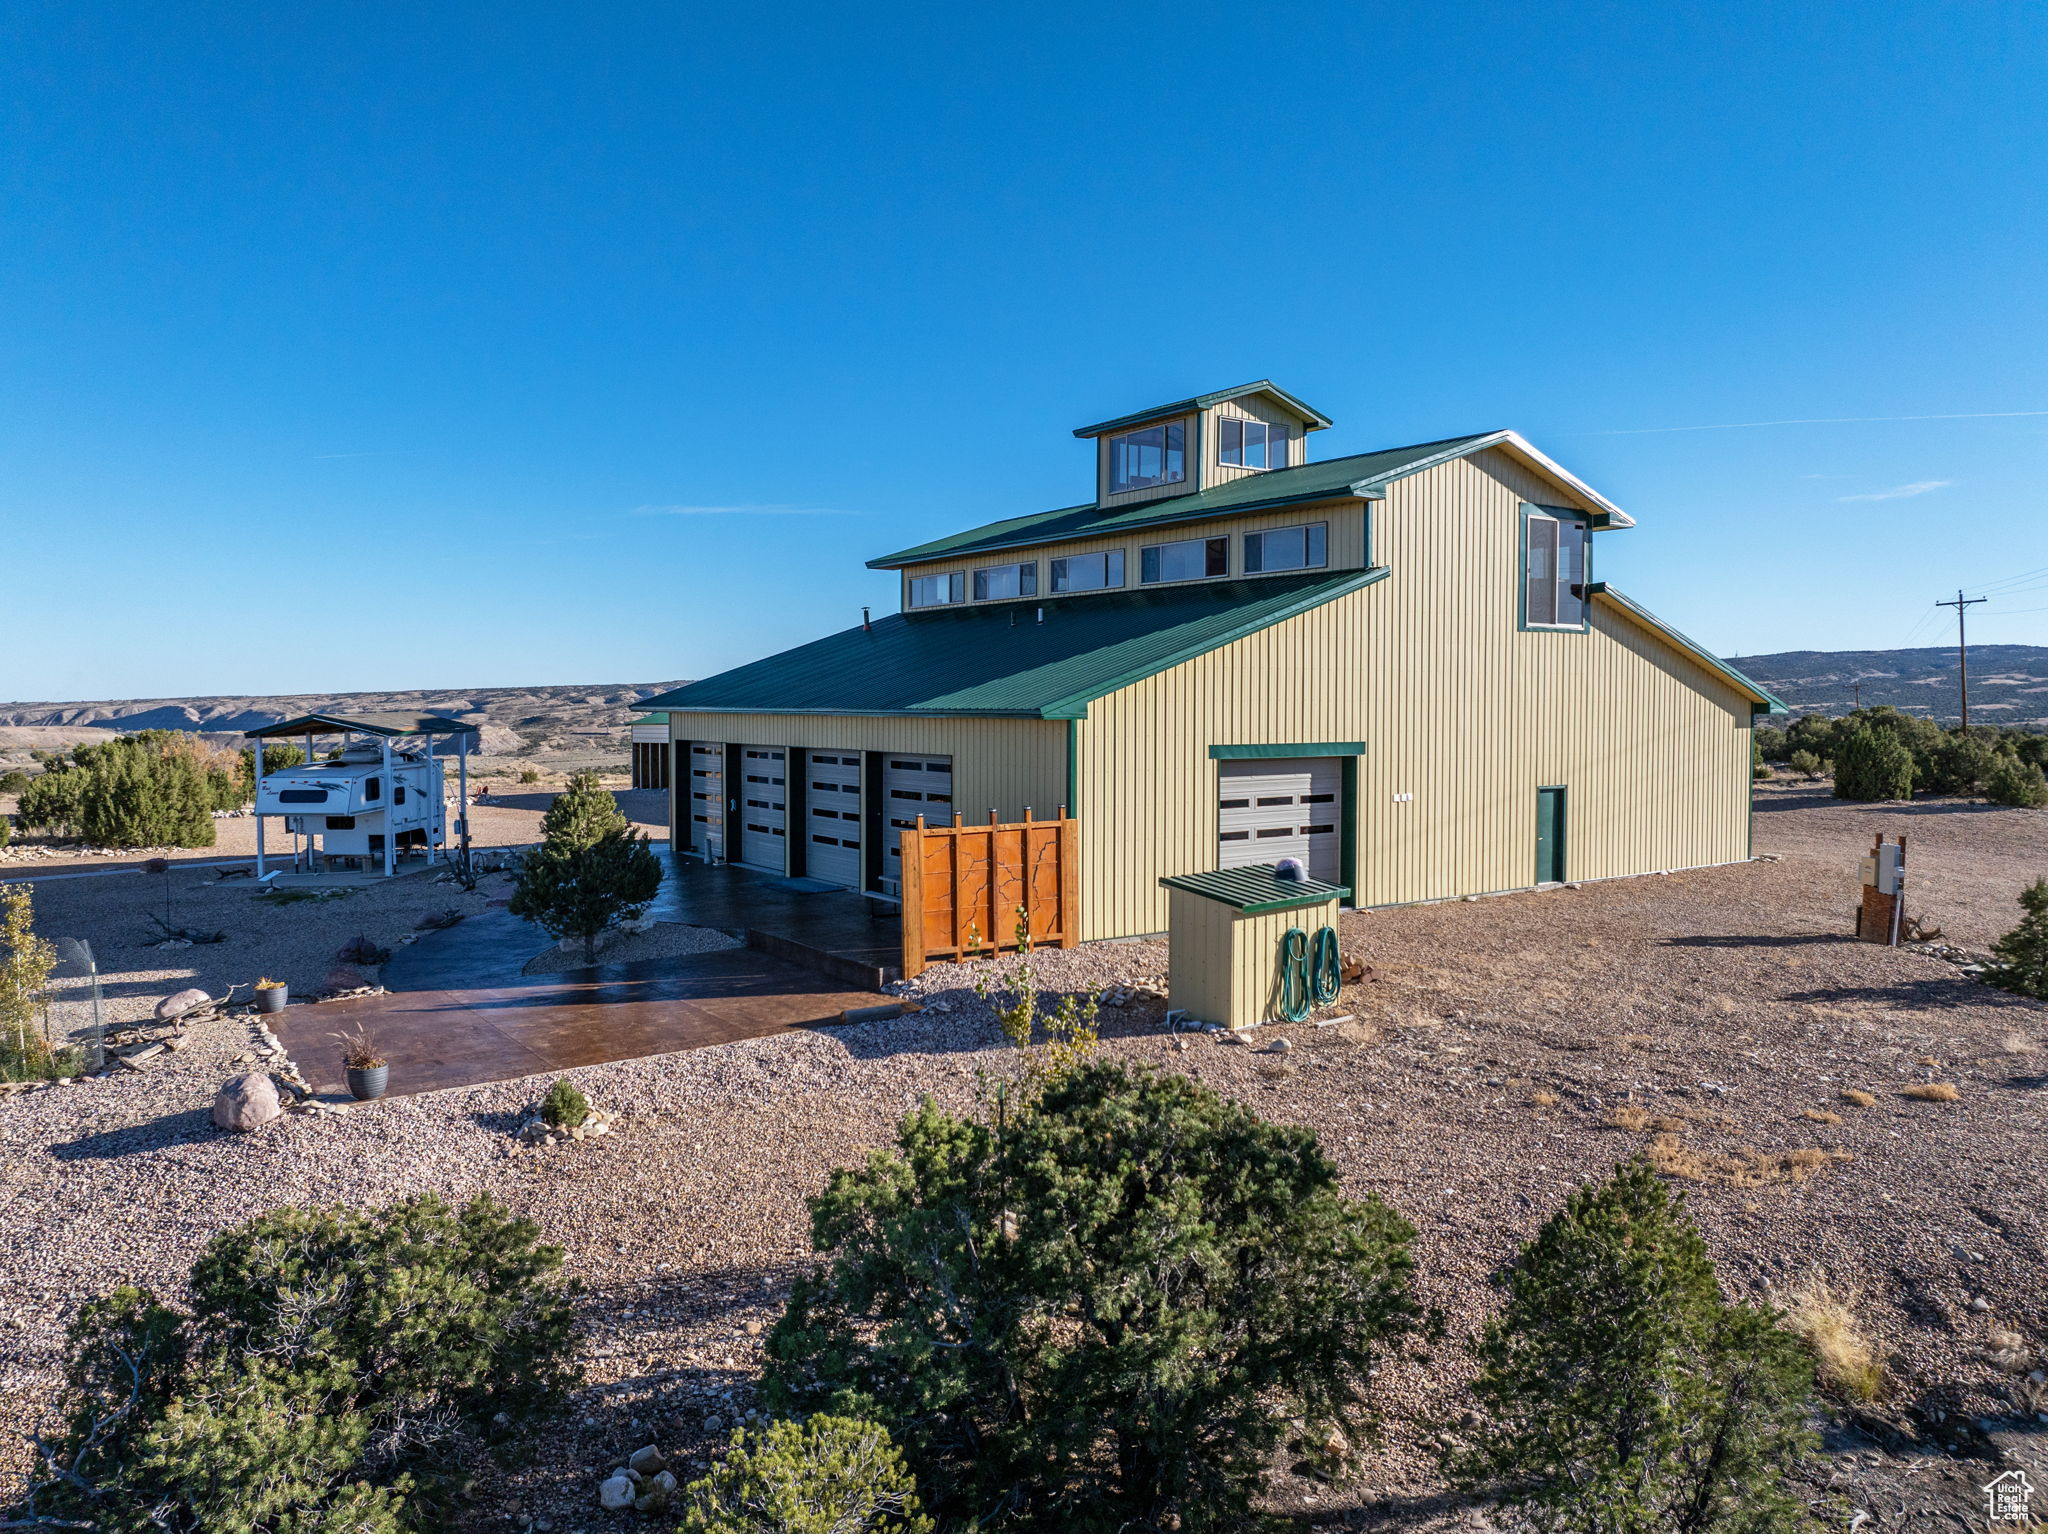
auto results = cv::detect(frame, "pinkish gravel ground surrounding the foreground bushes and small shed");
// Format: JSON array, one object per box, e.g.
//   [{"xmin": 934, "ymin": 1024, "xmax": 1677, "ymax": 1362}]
[{"xmin": 0, "ymin": 801, "xmax": 2048, "ymax": 1534}]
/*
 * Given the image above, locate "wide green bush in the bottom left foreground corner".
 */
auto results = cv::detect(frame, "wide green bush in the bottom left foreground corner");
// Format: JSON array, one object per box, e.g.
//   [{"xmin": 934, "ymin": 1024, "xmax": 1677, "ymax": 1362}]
[{"xmin": 16, "ymin": 1196, "xmax": 575, "ymax": 1534}]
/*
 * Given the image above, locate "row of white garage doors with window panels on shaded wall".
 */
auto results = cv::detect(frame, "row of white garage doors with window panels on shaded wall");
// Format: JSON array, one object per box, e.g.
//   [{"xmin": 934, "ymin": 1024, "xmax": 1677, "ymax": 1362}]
[{"xmin": 678, "ymin": 741, "xmax": 952, "ymax": 895}]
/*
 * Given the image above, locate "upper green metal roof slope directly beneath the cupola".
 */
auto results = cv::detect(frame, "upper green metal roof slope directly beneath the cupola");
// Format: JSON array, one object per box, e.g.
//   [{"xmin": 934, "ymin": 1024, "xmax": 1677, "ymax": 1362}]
[{"xmin": 868, "ymin": 432, "xmax": 1509, "ymax": 569}]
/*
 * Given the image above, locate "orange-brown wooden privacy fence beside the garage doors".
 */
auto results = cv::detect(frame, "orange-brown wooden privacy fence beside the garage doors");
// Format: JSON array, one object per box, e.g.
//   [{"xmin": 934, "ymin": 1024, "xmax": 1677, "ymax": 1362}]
[{"xmin": 903, "ymin": 805, "xmax": 1081, "ymax": 979}]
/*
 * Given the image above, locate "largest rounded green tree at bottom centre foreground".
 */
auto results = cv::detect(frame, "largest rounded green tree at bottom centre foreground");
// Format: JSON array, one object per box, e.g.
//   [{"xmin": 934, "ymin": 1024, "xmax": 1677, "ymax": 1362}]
[{"xmin": 766, "ymin": 1063, "xmax": 1419, "ymax": 1534}]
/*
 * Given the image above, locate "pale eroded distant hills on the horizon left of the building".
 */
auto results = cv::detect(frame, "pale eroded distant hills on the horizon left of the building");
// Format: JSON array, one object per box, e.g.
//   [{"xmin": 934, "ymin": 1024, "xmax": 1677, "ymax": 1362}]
[{"xmin": 0, "ymin": 682, "xmax": 682, "ymax": 758}]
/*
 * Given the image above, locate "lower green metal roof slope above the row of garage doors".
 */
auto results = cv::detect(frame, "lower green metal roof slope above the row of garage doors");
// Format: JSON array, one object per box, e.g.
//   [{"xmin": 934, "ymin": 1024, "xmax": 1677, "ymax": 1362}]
[{"xmin": 645, "ymin": 569, "xmax": 1386, "ymax": 719}]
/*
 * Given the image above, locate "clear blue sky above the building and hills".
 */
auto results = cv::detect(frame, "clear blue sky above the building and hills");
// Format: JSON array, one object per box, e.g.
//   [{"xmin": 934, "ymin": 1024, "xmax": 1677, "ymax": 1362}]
[{"xmin": 0, "ymin": 0, "xmax": 2048, "ymax": 700}]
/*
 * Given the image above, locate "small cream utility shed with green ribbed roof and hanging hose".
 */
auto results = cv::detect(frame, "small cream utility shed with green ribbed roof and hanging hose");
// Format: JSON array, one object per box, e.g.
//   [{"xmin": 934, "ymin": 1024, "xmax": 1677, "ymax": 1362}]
[{"xmin": 1159, "ymin": 862, "xmax": 1352, "ymax": 1028}]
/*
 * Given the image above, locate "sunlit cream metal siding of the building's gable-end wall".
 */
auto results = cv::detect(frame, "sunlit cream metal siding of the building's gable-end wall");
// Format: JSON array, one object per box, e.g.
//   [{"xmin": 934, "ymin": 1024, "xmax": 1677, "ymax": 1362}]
[{"xmin": 1075, "ymin": 453, "xmax": 1751, "ymax": 938}]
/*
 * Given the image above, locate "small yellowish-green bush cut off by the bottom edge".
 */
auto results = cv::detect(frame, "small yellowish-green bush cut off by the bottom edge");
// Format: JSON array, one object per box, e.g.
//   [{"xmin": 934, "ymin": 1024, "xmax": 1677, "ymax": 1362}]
[{"xmin": 680, "ymin": 1413, "xmax": 934, "ymax": 1534}]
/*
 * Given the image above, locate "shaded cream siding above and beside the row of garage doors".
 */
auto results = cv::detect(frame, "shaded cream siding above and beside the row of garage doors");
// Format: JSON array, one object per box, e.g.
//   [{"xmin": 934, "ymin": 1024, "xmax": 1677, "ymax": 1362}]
[{"xmin": 670, "ymin": 709, "xmax": 1067, "ymax": 843}]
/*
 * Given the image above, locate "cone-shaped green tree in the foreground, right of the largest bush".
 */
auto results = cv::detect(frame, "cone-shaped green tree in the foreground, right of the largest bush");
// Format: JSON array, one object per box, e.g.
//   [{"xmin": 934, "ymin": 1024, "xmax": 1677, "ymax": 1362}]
[{"xmin": 1444, "ymin": 1159, "xmax": 1815, "ymax": 1534}]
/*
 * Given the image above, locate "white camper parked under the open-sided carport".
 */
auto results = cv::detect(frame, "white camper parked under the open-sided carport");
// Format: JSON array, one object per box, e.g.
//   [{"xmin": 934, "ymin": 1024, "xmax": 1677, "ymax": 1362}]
[{"xmin": 248, "ymin": 713, "xmax": 477, "ymax": 879}]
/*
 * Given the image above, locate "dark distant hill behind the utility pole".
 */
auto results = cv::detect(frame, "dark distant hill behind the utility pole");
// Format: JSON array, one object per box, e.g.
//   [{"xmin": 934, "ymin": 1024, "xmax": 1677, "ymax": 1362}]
[{"xmin": 1729, "ymin": 645, "xmax": 2048, "ymax": 729}]
